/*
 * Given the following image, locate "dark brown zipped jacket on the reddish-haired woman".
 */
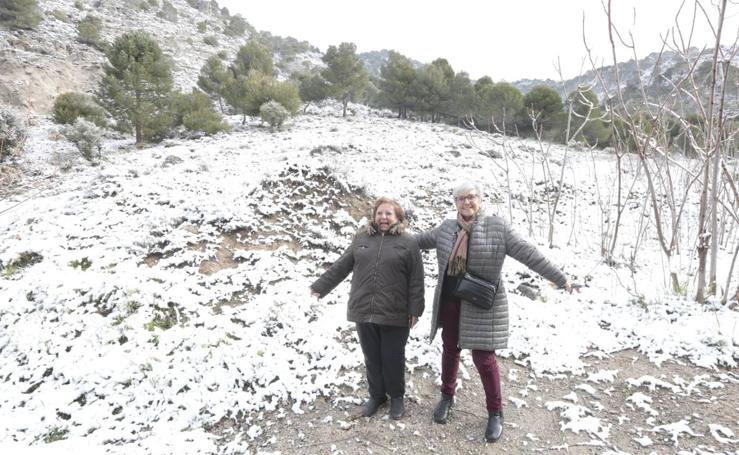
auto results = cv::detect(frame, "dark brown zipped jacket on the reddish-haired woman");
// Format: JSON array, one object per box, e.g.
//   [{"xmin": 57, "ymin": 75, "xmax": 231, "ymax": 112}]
[{"xmin": 310, "ymin": 224, "xmax": 424, "ymax": 327}]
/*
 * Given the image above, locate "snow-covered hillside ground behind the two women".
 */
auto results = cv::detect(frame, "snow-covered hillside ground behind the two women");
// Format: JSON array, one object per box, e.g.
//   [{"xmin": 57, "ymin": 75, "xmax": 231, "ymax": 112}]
[{"xmin": 0, "ymin": 105, "xmax": 739, "ymax": 454}]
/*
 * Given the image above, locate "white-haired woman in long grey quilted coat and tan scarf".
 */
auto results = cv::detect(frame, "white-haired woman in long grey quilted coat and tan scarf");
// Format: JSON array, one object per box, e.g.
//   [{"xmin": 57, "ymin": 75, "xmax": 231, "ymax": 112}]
[{"xmin": 416, "ymin": 182, "xmax": 572, "ymax": 442}]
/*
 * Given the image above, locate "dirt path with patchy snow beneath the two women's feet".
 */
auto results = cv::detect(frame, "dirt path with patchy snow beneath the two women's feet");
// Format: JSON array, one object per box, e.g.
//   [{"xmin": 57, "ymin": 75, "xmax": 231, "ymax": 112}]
[{"xmin": 246, "ymin": 351, "xmax": 739, "ymax": 455}]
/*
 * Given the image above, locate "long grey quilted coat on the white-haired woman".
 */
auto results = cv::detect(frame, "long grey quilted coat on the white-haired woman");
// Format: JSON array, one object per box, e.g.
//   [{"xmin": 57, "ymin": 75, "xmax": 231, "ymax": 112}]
[{"xmin": 416, "ymin": 216, "xmax": 567, "ymax": 351}]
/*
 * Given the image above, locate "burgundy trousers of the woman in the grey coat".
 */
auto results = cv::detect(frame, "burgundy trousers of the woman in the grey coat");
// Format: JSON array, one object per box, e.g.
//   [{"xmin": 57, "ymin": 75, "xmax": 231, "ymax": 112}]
[{"xmin": 439, "ymin": 298, "xmax": 503, "ymax": 411}]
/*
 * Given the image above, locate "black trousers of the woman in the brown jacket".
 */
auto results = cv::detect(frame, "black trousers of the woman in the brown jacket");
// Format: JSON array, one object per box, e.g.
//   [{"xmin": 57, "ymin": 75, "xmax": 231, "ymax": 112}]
[{"xmin": 357, "ymin": 322, "xmax": 411, "ymax": 399}]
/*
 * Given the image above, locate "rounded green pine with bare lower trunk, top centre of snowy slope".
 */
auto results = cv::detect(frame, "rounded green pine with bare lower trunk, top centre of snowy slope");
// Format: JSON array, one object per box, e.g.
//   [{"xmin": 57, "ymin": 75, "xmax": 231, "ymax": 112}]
[{"xmin": 321, "ymin": 43, "xmax": 369, "ymax": 117}]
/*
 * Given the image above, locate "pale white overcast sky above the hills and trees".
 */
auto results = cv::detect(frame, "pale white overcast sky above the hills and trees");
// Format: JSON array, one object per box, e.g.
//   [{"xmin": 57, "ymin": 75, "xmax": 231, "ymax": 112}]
[{"xmin": 219, "ymin": 0, "xmax": 739, "ymax": 81}]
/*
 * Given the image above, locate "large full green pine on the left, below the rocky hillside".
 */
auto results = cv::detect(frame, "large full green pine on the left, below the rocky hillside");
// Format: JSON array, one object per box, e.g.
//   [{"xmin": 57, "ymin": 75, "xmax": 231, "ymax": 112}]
[{"xmin": 100, "ymin": 30, "xmax": 172, "ymax": 144}]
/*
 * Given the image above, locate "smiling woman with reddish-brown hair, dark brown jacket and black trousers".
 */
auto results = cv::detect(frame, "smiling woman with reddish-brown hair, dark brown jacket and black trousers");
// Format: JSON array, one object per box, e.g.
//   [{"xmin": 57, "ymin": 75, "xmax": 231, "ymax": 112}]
[{"xmin": 310, "ymin": 198, "xmax": 424, "ymax": 420}]
